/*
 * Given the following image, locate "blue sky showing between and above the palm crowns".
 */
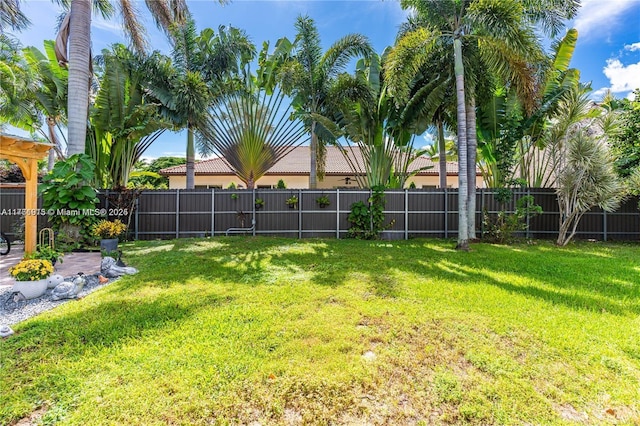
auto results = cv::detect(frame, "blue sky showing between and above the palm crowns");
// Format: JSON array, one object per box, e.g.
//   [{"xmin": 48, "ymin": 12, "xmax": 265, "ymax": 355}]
[{"xmin": 10, "ymin": 0, "xmax": 640, "ymax": 158}]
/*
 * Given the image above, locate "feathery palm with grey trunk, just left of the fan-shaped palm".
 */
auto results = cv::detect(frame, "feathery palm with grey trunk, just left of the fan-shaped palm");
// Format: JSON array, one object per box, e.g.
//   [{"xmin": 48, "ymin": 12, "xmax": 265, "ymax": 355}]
[{"xmin": 148, "ymin": 20, "xmax": 255, "ymax": 189}]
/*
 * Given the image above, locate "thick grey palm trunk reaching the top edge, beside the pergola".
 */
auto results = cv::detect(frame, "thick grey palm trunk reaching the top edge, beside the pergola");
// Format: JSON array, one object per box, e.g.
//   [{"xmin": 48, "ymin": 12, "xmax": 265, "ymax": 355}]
[{"xmin": 67, "ymin": 0, "xmax": 91, "ymax": 155}]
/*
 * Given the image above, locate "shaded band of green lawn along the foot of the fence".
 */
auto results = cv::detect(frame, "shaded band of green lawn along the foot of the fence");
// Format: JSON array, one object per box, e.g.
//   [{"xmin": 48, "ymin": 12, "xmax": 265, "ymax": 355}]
[{"xmin": 121, "ymin": 237, "xmax": 640, "ymax": 315}]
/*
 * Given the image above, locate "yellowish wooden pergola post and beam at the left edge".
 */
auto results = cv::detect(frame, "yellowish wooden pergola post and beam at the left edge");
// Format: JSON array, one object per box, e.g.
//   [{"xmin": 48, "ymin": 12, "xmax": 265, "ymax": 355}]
[{"xmin": 0, "ymin": 134, "xmax": 53, "ymax": 253}]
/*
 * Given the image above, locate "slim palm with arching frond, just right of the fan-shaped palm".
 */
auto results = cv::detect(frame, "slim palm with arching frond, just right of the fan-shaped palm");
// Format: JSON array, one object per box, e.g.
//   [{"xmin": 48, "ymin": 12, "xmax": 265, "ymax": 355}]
[{"xmin": 282, "ymin": 16, "xmax": 373, "ymax": 189}]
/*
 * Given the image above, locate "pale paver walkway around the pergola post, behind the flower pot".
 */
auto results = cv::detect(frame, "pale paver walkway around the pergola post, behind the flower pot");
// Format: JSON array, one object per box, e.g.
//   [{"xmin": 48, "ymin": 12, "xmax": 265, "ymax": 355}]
[{"xmin": 0, "ymin": 246, "xmax": 101, "ymax": 287}]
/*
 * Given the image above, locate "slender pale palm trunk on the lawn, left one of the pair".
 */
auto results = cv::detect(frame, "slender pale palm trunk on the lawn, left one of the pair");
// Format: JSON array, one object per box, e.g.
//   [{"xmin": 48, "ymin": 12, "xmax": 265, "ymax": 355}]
[{"xmin": 453, "ymin": 38, "xmax": 469, "ymax": 250}]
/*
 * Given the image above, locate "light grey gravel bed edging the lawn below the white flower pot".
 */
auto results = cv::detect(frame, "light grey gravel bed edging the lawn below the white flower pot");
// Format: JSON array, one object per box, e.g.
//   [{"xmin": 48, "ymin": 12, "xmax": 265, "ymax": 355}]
[{"xmin": 0, "ymin": 274, "xmax": 117, "ymax": 326}]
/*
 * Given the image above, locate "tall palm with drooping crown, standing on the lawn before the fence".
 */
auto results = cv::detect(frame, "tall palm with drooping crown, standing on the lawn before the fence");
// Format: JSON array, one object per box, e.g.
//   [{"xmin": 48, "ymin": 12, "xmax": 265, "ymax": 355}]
[{"xmin": 390, "ymin": 0, "xmax": 579, "ymax": 250}]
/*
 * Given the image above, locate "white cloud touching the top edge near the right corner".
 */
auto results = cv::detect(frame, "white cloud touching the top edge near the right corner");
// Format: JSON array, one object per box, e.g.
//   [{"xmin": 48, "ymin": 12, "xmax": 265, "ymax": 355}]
[{"xmin": 573, "ymin": 0, "xmax": 636, "ymax": 39}]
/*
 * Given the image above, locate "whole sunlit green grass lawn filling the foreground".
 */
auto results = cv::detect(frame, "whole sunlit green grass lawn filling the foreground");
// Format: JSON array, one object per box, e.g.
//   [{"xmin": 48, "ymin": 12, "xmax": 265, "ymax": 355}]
[{"xmin": 0, "ymin": 237, "xmax": 640, "ymax": 425}]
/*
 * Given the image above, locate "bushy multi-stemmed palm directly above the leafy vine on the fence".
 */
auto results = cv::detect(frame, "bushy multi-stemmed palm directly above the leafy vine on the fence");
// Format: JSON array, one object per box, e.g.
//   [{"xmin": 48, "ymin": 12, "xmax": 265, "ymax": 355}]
[{"xmin": 314, "ymin": 48, "xmax": 446, "ymax": 188}]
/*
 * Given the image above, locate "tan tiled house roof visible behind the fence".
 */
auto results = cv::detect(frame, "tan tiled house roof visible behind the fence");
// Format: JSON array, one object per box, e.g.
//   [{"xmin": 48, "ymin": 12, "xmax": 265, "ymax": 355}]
[{"xmin": 159, "ymin": 146, "xmax": 470, "ymax": 176}]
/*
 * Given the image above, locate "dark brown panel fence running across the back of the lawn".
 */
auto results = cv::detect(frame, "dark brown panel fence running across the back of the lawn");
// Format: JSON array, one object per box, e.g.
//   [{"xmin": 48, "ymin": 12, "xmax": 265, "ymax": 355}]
[{"xmin": 0, "ymin": 188, "xmax": 640, "ymax": 241}]
